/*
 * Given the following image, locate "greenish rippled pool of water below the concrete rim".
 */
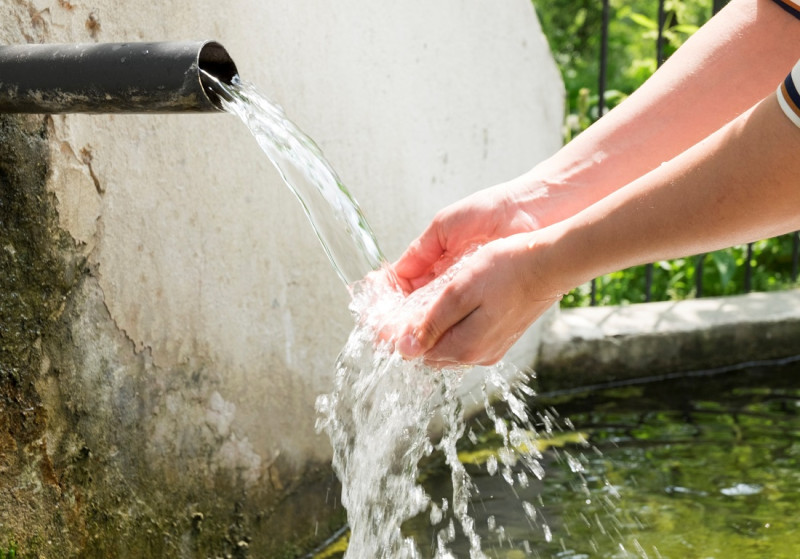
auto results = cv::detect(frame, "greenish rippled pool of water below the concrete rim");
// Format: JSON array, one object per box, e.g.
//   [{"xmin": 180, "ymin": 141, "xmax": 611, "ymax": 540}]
[{"xmin": 316, "ymin": 365, "xmax": 800, "ymax": 559}]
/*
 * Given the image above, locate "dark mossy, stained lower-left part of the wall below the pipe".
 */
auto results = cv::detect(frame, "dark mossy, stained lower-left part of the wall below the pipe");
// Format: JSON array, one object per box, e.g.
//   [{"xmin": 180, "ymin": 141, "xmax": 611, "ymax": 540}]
[{"xmin": 0, "ymin": 115, "xmax": 344, "ymax": 559}]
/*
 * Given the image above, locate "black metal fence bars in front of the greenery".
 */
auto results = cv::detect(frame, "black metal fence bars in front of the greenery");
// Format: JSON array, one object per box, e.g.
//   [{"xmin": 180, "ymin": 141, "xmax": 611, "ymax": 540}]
[{"xmin": 589, "ymin": 0, "xmax": 800, "ymax": 306}]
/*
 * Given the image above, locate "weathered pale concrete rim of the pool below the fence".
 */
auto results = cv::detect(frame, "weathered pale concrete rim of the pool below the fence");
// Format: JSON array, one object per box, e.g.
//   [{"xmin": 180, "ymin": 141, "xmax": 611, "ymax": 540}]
[{"xmin": 536, "ymin": 289, "xmax": 800, "ymax": 391}]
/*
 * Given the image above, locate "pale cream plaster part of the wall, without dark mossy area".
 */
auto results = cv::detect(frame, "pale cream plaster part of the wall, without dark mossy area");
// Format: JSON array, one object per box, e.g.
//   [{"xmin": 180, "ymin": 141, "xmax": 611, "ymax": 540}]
[{"xmin": 0, "ymin": 0, "xmax": 562, "ymax": 552}]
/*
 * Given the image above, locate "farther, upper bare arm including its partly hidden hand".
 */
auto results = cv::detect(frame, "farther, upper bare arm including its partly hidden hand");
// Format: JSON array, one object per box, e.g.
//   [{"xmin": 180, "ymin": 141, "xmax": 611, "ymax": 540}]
[{"xmin": 395, "ymin": 0, "xmax": 800, "ymax": 284}]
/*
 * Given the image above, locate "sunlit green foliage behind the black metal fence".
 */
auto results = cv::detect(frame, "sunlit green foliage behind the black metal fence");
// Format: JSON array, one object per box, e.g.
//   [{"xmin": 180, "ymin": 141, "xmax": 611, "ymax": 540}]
[{"xmin": 533, "ymin": 0, "xmax": 796, "ymax": 307}]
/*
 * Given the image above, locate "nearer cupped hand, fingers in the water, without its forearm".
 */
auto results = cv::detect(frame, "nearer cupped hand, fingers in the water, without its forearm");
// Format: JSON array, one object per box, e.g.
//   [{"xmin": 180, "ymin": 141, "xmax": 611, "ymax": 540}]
[{"xmin": 389, "ymin": 234, "xmax": 560, "ymax": 367}]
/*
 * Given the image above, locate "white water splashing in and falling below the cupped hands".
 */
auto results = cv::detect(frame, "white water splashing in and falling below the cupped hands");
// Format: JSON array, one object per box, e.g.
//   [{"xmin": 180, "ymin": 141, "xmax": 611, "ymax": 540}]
[{"xmin": 317, "ymin": 264, "xmax": 551, "ymax": 559}]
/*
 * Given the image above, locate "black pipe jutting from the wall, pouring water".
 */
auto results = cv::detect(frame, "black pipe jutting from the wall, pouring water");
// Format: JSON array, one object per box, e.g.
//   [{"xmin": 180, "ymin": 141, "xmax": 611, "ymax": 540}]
[{"xmin": 0, "ymin": 41, "xmax": 237, "ymax": 113}]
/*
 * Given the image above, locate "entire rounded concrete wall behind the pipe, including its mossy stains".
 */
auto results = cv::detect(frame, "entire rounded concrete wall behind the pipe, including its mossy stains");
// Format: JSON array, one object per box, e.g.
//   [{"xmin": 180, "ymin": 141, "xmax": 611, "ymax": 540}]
[{"xmin": 0, "ymin": 0, "xmax": 562, "ymax": 557}]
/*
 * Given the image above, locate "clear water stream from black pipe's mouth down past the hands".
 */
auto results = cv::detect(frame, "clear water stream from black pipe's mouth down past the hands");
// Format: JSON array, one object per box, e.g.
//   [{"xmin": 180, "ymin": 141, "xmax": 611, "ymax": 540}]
[{"xmin": 205, "ymin": 75, "xmax": 636, "ymax": 559}]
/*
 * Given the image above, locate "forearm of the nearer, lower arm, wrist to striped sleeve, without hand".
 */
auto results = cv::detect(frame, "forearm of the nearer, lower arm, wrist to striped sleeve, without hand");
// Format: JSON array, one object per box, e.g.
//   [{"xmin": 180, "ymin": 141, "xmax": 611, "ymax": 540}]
[{"xmin": 534, "ymin": 95, "xmax": 800, "ymax": 298}]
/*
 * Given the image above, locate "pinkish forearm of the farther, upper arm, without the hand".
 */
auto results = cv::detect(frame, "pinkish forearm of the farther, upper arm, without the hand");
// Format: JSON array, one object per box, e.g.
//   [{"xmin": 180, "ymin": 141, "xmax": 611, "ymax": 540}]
[{"xmin": 520, "ymin": 0, "xmax": 800, "ymax": 225}]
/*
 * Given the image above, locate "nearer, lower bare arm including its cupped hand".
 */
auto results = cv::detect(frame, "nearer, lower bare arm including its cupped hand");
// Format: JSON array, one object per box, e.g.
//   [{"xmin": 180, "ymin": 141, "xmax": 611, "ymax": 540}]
[{"xmin": 397, "ymin": 89, "xmax": 800, "ymax": 365}]
